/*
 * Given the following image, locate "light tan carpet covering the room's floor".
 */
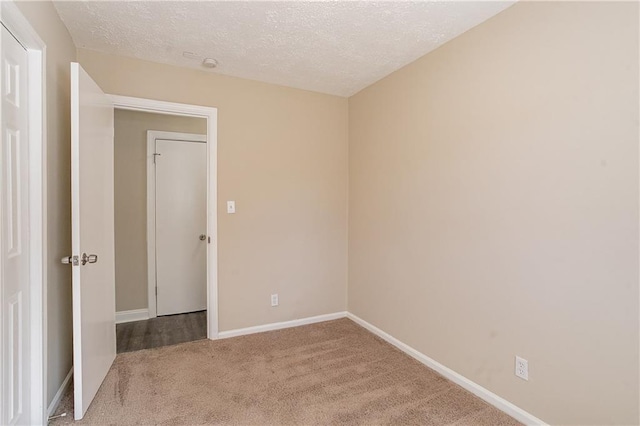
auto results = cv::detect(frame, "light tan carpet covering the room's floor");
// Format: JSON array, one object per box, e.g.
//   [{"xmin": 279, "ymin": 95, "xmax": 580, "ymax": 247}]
[{"xmin": 51, "ymin": 319, "xmax": 519, "ymax": 426}]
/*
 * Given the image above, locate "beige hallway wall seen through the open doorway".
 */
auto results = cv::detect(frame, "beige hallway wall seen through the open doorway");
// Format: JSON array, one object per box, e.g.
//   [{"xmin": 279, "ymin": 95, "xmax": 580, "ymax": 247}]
[{"xmin": 114, "ymin": 110, "xmax": 207, "ymax": 312}]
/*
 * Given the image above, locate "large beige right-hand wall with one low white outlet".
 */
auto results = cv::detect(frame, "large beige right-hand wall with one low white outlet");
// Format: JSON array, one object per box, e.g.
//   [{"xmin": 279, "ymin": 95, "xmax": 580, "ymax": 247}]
[{"xmin": 348, "ymin": 2, "xmax": 639, "ymax": 424}]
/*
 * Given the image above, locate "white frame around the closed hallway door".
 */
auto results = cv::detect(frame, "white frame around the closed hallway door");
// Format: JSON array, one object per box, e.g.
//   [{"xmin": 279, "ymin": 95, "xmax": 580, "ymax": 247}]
[{"xmin": 147, "ymin": 130, "xmax": 209, "ymax": 318}]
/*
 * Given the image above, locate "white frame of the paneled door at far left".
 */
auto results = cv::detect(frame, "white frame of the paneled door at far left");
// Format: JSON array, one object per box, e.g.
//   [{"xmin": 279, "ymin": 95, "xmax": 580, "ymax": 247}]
[{"xmin": 0, "ymin": 1, "xmax": 48, "ymax": 425}]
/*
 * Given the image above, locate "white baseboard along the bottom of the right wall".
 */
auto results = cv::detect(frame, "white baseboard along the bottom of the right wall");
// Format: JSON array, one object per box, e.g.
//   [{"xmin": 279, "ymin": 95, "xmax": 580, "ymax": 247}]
[{"xmin": 347, "ymin": 313, "xmax": 546, "ymax": 425}]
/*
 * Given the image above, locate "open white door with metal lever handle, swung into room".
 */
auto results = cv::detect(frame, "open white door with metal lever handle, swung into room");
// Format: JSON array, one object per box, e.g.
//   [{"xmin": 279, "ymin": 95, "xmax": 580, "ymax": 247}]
[{"xmin": 71, "ymin": 63, "xmax": 116, "ymax": 420}]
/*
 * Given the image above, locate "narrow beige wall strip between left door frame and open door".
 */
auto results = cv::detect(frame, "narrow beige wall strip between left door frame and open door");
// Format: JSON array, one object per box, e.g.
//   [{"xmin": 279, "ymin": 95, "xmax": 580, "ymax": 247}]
[{"xmin": 16, "ymin": 2, "xmax": 76, "ymax": 402}]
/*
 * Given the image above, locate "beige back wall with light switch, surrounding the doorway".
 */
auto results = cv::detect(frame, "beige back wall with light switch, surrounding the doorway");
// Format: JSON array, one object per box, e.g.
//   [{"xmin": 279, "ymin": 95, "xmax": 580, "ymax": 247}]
[{"xmin": 78, "ymin": 49, "xmax": 348, "ymax": 331}]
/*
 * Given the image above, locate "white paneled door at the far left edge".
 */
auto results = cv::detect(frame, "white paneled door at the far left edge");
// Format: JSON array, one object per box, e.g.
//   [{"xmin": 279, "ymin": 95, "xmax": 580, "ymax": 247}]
[{"xmin": 0, "ymin": 26, "xmax": 31, "ymax": 425}]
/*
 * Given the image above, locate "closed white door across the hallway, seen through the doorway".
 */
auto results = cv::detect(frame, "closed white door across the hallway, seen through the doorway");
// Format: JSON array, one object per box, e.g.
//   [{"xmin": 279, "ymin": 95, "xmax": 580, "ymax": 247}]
[{"xmin": 155, "ymin": 140, "xmax": 207, "ymax": 315}]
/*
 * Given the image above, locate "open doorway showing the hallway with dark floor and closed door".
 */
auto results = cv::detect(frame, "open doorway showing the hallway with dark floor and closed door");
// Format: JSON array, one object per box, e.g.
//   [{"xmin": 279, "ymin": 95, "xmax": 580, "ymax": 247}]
[{"xmin": 114, "ymin": 106, "xmax": 216, "ymax": 353}]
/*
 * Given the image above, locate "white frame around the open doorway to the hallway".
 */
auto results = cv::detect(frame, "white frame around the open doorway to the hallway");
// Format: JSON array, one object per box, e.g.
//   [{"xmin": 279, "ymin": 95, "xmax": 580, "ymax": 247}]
[{"xmin": 108, "ymin": 95, "xmax": 218, "ymax": 339}]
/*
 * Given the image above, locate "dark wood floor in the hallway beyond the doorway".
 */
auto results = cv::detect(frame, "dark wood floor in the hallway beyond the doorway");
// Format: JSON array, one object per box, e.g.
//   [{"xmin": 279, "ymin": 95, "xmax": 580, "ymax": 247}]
[{"xmin": 116, "ymin": 311, "xmax": 207, "ymax": 353}]
